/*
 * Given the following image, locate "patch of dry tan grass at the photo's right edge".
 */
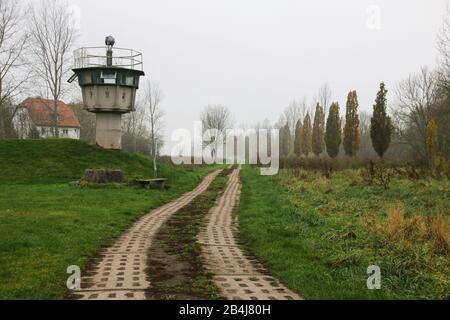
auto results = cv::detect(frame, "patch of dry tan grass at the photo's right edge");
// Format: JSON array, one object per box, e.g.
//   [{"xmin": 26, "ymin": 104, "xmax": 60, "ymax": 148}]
[{"xmin": 363, "ymin": 205, "xmax": 450, "ymax": 256}]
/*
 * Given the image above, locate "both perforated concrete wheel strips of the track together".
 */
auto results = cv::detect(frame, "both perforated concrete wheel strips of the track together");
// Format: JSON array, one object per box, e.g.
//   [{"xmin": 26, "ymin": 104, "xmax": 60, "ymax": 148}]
[{"xmin": 71, "ymin": 170, "xmax": 301, "ymax": 300}]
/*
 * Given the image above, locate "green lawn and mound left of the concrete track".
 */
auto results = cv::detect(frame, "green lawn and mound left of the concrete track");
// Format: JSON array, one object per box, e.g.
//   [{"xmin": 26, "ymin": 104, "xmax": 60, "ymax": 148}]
[{"xmin": 0, "ymin": 140, "xmax": 213, "ymax": 299}]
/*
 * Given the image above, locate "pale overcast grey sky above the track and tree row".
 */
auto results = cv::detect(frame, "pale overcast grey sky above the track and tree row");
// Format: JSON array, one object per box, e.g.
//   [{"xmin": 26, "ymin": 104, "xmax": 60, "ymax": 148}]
[{"xmin": 69, "ymin": 0, "xmax": 449, "ymax": 151}]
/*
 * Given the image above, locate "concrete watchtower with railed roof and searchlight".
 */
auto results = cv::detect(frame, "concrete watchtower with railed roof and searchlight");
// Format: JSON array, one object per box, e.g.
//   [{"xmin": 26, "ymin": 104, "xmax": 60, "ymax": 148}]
[{"xmin": 69, "ymin": 36, "xmax": 144, "ymax": 149}]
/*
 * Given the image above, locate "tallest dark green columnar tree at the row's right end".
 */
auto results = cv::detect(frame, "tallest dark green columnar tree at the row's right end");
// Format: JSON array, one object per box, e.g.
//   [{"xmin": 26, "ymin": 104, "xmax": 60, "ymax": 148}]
[{"xmin": 370, "ymin": 83, "xmax": 393, "ymax": 158}]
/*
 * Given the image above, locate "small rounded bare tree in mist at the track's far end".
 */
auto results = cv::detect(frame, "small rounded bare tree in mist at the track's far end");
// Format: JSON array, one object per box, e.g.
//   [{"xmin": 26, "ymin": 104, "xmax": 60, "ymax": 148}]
[{"xmin": 200, "ymin": 105, "xmax": 233, "ymax": 159}]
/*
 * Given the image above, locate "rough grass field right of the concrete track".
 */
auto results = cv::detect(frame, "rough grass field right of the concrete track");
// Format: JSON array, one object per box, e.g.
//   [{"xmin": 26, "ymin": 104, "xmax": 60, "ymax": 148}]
[{"xmin": 237, "ymin": 167, "xmax": 450, "ymax": 299}]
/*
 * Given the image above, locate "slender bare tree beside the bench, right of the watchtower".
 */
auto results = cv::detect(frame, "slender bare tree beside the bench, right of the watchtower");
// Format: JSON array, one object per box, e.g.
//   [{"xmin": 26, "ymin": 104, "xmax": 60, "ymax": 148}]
[{"xmin": 144, "ymin": 81, "xmax": 164, "ymax": 177}]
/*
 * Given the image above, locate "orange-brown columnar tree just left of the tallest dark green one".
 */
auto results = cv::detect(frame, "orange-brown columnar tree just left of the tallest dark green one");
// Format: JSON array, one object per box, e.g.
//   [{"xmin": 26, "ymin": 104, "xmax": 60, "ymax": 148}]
[{"xmin": 344, "ymin": 91, "xmax": 360, "ymax": 157}]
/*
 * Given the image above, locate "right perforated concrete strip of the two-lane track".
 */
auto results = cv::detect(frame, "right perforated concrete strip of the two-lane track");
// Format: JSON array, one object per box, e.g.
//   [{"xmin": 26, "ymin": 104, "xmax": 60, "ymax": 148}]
[{"xmin": 199, "ymin": 170, "xmax": 300, "ymax": 300}]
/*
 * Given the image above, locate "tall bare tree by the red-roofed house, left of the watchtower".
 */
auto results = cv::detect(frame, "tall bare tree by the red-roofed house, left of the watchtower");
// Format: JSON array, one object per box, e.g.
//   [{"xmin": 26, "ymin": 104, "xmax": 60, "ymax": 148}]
[{"xmin": 29, "ymin": 0, "xmax": 76, "ymax": 137}]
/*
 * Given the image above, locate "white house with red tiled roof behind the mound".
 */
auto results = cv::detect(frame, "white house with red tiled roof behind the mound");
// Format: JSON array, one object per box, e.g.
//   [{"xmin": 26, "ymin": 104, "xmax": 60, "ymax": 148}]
[{"xmin": 15, "ymin": 98, "xmax": 81, "ymax": 140}]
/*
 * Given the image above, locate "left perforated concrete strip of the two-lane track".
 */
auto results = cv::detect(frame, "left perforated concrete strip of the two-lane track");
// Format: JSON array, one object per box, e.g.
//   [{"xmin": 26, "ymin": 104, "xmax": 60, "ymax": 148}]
[{"xmin": 72, "ymin": 171, "xmax": 219, "ymax": 300}]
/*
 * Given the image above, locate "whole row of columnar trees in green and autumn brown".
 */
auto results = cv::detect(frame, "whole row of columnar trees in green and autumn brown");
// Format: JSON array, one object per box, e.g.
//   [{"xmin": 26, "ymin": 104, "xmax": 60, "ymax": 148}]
[{"xmin": 280, "ymin": 83, "xmax": 394, "ymax": 158}]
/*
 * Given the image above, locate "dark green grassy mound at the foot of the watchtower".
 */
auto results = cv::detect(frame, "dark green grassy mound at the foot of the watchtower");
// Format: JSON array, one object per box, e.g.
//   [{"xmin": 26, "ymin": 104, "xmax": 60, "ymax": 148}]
[{"xmin": 0, "ymin": 139, "xmax": 156, "ymax": 183}]
